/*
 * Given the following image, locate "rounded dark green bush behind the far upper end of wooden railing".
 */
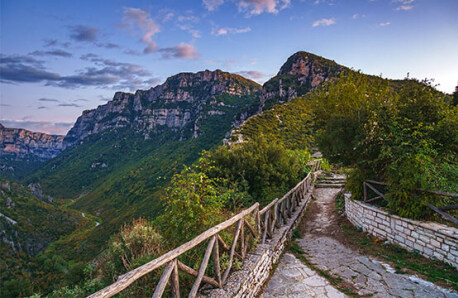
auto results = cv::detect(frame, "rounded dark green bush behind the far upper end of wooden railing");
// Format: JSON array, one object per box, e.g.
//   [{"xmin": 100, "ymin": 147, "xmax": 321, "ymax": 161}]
[{"xmin": 201, "ymin": 135, "xmax": 309, "ymax": 207}]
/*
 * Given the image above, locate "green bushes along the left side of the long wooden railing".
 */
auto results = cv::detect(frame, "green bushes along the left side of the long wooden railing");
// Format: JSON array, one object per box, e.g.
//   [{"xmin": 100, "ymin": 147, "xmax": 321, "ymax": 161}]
[{"xmin": 35, "ymin": 136, "xmax": 308, "ymax": 297}]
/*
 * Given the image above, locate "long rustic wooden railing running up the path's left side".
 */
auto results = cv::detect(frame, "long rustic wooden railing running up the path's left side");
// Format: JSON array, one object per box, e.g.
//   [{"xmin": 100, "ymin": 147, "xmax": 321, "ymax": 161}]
[{"xmin": 89, "ymin": 160, "xmax": 321, "ymax": 298}]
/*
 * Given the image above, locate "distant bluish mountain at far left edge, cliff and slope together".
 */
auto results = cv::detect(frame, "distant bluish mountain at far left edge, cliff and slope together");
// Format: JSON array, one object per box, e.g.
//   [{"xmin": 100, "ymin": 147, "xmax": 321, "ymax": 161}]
[{"xmin": 0, "ymin": 124, "xmax": 64, "ymax": 178}]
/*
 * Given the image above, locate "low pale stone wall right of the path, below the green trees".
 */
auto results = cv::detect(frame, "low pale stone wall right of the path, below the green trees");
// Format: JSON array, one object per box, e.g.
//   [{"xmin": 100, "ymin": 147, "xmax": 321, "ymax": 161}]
[{"xmin": 345, "ymin": 196, "xmax": 458, "ymax": 269}]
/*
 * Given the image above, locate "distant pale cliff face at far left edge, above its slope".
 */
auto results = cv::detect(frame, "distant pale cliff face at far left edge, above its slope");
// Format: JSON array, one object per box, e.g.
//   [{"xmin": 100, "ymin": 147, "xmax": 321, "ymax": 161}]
[{"xmin": 0, "ymin": 124, "xmax": 64, "ymax": 160}]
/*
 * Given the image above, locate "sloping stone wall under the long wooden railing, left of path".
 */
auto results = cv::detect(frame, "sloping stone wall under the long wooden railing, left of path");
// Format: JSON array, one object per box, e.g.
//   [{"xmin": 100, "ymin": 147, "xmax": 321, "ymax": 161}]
[{"xmin": 200, "ymin": 193, "xmax": 311, "ymax": 297}]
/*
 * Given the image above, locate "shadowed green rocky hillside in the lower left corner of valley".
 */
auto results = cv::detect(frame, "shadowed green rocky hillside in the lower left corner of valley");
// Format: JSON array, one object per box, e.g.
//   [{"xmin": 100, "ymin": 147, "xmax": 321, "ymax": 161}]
[{"xmin": 0, "ymin": 180, "xmax": 90, "ymax": 297}]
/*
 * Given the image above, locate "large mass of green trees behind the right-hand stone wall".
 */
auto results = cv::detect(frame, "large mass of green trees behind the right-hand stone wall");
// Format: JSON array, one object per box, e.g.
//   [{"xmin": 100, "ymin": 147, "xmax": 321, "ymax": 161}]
[{"xmin": 310, "ymin": 72, "xmax": 458, "ymax": 218}]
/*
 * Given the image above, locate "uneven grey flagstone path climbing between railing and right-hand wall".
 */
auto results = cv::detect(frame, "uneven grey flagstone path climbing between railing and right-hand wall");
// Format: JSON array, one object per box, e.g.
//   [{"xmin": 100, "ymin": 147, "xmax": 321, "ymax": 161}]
[{"xmin": 261, "ymin": 178, "xmax": 458, "ymax": 298}]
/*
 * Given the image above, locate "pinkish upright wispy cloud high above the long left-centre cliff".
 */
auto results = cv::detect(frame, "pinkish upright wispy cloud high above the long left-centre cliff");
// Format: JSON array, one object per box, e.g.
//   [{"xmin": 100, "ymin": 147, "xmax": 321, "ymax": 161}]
[{"xmin": 122, "ymin": 7, "xmax": 160, "ymax": 54}]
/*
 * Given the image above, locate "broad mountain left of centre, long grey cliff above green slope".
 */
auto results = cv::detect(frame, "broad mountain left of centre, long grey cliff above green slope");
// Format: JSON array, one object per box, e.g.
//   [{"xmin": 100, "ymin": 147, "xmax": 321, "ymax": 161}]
[{"xmin": 26, "ymin": 70, "xmax": 261, "ymax": 260}]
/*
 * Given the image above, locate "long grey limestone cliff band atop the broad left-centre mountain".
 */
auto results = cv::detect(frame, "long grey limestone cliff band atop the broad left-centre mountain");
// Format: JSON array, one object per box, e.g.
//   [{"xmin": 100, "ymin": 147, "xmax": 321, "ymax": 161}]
[{"xmin": 64, "ymin": 70, "xmax": 260, "ymax": 148}]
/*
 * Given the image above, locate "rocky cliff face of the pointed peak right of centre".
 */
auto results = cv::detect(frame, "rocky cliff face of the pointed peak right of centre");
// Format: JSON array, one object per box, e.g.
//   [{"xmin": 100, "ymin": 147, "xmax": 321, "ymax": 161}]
[{"xmin": 259, "ymin": 52, "xmax": 347, "ymax": 111}]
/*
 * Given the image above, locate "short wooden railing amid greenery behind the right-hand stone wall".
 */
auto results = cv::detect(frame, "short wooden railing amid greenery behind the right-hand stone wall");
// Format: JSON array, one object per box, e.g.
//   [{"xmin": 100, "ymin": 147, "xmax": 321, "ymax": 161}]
[{"xmin": 363, "ymin": 180, "xmax": 458, "ymax": 225}]
